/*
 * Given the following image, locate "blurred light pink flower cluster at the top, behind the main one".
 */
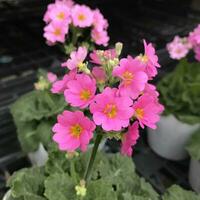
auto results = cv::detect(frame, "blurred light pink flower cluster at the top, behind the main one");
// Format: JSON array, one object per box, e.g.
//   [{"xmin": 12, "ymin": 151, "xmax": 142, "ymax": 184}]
[{"xmin": 43, "ymin": 0, "xmax": 109, "ymax": 46}]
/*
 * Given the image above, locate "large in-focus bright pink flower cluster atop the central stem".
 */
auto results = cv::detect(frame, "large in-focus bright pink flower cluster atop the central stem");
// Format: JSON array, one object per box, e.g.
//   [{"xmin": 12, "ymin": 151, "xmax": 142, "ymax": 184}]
[{"xmin": 51, "ymin": 41, "xmax": 164, "ymax": 156}]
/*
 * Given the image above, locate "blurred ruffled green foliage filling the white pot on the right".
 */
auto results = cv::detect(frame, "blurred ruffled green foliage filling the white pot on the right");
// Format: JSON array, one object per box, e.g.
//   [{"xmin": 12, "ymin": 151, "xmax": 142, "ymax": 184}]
[{"xmin": 158, "ymin": 60, "xmax": 200, "ymax": 124}]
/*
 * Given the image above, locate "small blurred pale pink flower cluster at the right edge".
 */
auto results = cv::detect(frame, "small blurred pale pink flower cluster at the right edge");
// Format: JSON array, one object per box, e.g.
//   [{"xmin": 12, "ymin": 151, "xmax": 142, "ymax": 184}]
[{"xmin": 167, "ymin": 25, "xmax": 200, "ymax": 61}]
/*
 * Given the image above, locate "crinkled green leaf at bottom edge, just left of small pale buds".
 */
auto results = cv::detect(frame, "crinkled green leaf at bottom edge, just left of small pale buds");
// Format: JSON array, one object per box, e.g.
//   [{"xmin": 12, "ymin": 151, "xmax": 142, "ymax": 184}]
[{"xmin": 44, "ymin": 173, "xmax": 76, "ymax": 200}]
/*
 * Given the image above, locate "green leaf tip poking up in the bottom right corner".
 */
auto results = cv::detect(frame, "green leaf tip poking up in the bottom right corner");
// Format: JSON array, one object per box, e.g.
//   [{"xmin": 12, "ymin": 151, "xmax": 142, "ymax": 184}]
[{"xmin": 162, "ymin": 185, "xmax": 200, "ymax": 200}]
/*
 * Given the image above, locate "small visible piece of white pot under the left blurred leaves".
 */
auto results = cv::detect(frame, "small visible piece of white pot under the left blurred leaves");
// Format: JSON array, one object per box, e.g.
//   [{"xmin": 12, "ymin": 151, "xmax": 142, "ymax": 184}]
[{"xmin": 28, "ymin": 144, "xmax": 48, "ymax": 166}]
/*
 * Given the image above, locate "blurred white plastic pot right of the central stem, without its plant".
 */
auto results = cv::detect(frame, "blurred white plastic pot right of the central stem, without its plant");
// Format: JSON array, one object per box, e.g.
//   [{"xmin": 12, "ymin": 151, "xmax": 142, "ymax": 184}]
[{"xmin": 148, "ymin": 115, "xmax": 199, "ymax": 160}]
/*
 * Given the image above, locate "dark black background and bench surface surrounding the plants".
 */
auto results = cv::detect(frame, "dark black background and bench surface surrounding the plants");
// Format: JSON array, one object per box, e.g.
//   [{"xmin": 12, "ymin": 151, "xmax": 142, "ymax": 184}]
[{"xmin": 0, "ymin": 0, "xmax": 200, "ymax": 198}]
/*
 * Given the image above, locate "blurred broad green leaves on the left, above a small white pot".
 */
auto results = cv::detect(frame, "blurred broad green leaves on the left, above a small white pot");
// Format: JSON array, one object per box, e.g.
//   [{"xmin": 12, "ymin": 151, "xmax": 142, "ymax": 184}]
[{"xmin": 11, "ymin": 90, "xmax": 66, "ymax": 152}]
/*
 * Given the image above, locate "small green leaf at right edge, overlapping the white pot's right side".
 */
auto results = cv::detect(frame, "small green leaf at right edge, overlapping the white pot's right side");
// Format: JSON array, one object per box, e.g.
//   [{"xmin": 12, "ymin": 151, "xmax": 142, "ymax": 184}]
[{"xmin": 186, "ymin": 129, "xmax": 200, "ymax": 161}]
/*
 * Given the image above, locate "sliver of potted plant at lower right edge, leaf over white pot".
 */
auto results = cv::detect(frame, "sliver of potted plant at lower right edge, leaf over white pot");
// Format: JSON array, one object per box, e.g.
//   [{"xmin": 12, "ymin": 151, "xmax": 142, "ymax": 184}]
[{"xmin": 187, "ymin": 130, "xmax": 200, "ymax": 193}]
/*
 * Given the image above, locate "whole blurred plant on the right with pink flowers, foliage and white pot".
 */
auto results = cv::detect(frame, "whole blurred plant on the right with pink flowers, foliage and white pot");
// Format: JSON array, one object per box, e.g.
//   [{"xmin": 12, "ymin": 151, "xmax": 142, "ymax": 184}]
[{"xmin": 148, "ymin": 23, "xmax": 200, "ymax": 160}]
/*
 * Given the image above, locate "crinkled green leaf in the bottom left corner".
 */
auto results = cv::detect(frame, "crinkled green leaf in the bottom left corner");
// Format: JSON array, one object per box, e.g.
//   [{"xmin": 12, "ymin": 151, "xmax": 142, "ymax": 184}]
[{"xmin": 7, "ymin": 167, "xmax": 45, "ymax": 200}]
